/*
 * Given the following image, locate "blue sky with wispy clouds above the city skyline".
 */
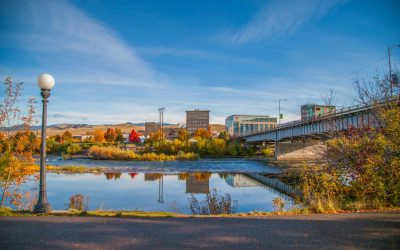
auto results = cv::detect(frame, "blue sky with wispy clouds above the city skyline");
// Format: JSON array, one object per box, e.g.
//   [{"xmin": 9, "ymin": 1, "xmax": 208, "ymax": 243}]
[{"xmin": 0, "ymin": 0, "xmax": 400, "ymax": 124}]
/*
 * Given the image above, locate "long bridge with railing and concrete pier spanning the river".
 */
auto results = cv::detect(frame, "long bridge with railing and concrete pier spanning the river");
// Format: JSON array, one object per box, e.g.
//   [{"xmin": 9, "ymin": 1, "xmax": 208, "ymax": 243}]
[{"xmin": 237, "ymin": 97, "xmax": 399, "ymax": 161}]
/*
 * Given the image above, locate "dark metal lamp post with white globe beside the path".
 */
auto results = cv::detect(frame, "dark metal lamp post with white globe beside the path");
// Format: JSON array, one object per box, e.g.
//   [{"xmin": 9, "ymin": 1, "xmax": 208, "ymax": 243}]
[{"xmin": 33, "ymin": 74, "xmax": 55, "ymax": 213}]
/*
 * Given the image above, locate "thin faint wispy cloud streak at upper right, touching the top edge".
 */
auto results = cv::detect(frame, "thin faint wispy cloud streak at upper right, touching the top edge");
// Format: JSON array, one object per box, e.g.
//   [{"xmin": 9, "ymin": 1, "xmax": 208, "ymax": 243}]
[{"xmin": 218, "ymin": 0, "xmax": 345, "ymax": 44}]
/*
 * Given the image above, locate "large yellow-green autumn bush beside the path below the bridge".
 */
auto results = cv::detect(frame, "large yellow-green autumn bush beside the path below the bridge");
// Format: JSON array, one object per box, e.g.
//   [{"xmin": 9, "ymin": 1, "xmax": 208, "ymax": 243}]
[{"xmin": 297, "ymin": 106, "xmax": 400, "ymax": 212}]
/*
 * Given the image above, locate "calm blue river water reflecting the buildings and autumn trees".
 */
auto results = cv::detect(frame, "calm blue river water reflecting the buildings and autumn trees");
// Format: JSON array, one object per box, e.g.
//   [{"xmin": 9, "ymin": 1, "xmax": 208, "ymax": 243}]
[{"xmin": 26, "ymin": 159, "xmax": 292, "ymax": 213}]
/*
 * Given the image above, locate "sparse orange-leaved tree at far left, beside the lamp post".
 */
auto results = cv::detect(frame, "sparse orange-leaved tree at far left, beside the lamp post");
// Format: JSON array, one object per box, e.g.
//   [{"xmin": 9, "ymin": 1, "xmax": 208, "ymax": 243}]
[{"xmin": 0, "ymin": 78, "xmax": 37, "ymax": 207}]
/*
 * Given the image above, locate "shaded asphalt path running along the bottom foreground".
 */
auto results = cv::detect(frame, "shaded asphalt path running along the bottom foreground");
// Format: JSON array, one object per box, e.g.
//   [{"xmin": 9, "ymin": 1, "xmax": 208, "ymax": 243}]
[{"xmin": 0, "ymin": 211, "xmax": 400, "ymax": 249}]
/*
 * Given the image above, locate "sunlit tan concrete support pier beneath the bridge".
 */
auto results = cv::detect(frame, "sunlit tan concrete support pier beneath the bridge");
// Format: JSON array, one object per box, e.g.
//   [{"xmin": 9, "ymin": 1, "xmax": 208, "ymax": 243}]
[{"xmin": 275, "ymin": 141, "xmax": 327, "ymax": 161}]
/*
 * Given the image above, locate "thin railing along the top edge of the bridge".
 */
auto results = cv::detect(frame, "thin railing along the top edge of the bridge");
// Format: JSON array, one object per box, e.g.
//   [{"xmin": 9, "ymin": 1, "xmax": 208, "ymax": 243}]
[{"xmin": 239, "ymin": 96, "xmax": 400, "ymax": 137}]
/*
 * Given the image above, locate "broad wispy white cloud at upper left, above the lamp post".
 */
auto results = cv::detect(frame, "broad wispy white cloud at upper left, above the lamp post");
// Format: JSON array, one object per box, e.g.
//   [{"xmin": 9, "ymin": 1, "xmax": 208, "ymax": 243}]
[{"xmin": 9, "ymin": 0, "xmax": 162, "ymax": 86}]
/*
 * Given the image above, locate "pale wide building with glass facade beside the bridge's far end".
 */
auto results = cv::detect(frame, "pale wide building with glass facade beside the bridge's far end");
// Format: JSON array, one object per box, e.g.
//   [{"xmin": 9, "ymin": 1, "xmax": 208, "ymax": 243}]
[{"xmin": 225, "ymin": 115, "xmax": 277, "ymax": 136}]
